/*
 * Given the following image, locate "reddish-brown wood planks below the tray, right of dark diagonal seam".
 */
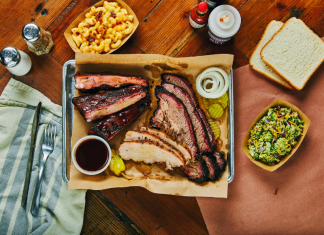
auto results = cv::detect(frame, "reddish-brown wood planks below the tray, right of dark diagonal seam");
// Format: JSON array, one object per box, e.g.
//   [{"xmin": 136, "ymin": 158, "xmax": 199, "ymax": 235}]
[{"xmin": 102, "ymin": 187, "xmax": 208, "ymax": 235}]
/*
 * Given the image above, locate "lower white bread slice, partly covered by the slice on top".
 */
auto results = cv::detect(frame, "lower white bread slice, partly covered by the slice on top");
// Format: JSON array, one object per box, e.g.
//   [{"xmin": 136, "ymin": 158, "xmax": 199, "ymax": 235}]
[{"xmin": 250, "ymin": 20, "xmax": 294, "ymax": 90}]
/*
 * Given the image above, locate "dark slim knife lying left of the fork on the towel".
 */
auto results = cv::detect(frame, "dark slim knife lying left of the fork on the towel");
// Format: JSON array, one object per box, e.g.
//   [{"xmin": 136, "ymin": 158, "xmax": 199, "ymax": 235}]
[{"xmin": 21, "ymin": 102, "xmax": 42, "ymax": 208}]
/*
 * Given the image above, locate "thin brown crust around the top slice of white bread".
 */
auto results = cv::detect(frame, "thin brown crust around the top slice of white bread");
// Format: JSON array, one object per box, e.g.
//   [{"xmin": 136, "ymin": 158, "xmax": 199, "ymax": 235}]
[{"xmin": 260, "ymin": 17, "xmax": 324, "ymax": 91}]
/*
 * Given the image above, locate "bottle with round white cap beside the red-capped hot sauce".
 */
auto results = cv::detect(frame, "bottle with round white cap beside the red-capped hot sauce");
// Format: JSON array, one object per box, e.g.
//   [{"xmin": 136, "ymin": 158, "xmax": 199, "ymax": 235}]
[{"xmin": 208, "ymin": 5, "xmax": 241, "ymax": 45}]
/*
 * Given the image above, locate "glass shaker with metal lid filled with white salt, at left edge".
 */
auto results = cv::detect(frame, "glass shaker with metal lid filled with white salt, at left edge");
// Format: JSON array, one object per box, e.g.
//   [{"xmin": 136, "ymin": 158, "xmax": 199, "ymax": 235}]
[{"xmin": 0, "ymin": 47, "xmax": 32, "ymax": 76}]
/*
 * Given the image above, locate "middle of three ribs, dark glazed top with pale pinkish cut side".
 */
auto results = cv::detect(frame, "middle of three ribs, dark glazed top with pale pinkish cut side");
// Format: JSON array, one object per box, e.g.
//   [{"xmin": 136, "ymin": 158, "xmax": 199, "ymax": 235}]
[{"xmin": 72, "ymin": 85, "xmax": 147, "ymax": 122}]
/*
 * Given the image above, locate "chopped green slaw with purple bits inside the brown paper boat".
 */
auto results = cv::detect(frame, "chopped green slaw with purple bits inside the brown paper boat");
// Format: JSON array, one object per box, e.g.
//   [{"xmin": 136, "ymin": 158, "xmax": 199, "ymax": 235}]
[{"xmin": 248, "ymin": 106, "xmax": 304, "ymax": 166}]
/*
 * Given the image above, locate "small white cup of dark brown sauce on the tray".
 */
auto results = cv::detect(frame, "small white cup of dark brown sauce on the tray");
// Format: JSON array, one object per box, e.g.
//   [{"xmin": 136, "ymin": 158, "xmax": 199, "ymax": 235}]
[{"xmin": 72, "ymin": 135, "xmax": 111, "ymax": 175}]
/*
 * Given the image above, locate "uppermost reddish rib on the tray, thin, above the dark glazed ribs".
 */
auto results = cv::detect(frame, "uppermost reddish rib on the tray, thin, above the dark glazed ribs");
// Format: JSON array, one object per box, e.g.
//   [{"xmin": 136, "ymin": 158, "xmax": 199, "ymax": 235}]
[{"xmin": 74, "ymin": 74, "xmax": 148, "ymax": 92}]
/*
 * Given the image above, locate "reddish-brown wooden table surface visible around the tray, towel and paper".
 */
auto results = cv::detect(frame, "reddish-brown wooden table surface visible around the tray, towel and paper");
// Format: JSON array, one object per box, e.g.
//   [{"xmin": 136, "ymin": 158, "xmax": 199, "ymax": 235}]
[{"xmin": 0, "ymin": 0, "xmax": 324, "ymax": 234}]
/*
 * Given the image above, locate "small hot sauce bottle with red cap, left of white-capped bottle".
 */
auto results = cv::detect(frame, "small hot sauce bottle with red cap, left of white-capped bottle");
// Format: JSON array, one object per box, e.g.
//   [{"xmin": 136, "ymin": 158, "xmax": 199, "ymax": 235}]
[{"xmin": 189, "ymin": 2, "xmax": 209, "ymax": 29}]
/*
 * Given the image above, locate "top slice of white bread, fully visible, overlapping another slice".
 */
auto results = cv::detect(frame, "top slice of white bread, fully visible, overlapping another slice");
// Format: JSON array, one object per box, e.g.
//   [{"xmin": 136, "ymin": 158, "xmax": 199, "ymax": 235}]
[{"xmin": 261, "ymin": 18, "xmax": 324, "ymax": 90}]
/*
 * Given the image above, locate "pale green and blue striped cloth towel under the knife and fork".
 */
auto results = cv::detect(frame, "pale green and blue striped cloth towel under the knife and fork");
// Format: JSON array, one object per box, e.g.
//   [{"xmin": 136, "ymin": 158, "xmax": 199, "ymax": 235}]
[{"xmin": 0, "ymin": 79, "xmax": 86, "ymax": 234}]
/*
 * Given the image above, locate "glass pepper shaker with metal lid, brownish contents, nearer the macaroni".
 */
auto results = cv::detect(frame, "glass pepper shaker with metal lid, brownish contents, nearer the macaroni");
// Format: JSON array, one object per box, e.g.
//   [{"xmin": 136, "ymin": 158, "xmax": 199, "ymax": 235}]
[{"xmin": 22, "ymin": 23, "xmax": 54, "ymax": 55}]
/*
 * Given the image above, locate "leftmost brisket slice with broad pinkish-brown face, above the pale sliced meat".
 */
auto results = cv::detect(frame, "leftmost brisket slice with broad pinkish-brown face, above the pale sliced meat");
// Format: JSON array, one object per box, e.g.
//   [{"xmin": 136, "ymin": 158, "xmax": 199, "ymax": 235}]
[{"xmin": 150, "ymin": 87, "xmax": 198, "ymax": 157}]
